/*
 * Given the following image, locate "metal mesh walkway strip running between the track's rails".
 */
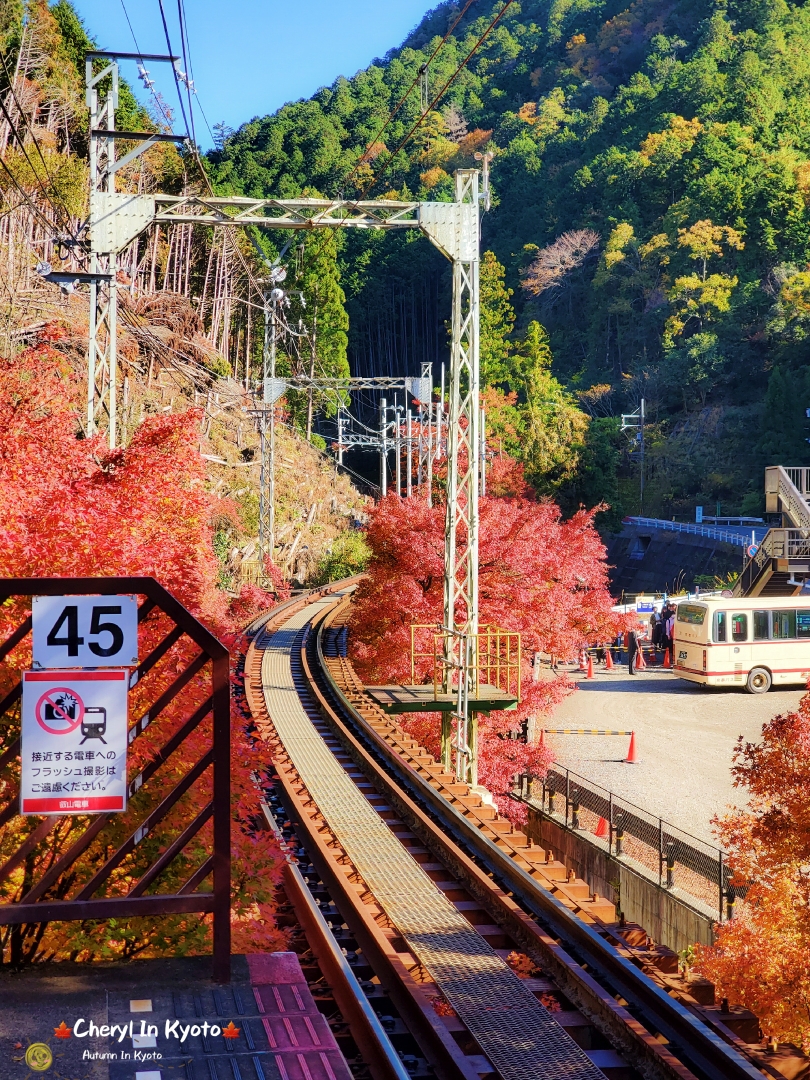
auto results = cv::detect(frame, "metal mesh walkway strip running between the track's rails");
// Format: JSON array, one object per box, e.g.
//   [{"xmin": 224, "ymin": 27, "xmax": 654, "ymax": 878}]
[{"xmin": 260, "ymin": 600, "xmax": 605, "ymax": 1080}]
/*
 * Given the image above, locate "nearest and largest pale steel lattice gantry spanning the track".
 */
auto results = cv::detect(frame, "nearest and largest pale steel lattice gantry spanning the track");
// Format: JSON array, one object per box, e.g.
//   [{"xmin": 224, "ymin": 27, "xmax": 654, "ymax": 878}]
[{"xmin": 77, "ymin": 52, "xmax": 481, "ymax": 783}]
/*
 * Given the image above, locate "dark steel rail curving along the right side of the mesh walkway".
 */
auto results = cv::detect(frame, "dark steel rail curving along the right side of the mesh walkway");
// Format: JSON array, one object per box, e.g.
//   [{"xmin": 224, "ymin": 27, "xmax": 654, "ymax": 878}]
[{"xmin": 313, "ymin": 600, "xmax": 762, "ymax": 1080}]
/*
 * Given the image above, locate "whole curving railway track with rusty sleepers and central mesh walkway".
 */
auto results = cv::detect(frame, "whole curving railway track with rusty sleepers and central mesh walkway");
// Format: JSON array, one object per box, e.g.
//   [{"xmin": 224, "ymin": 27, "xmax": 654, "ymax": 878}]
[{"xmin": 245, "ymin": 583, "xmax": 779, "ymax": 1080}]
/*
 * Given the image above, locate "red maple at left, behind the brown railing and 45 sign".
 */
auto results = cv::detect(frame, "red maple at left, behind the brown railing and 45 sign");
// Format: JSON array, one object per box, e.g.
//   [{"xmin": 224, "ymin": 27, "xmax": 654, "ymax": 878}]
[{"xmin": 0, "ymin": 327, "xmax": 284, "ymax": 959}]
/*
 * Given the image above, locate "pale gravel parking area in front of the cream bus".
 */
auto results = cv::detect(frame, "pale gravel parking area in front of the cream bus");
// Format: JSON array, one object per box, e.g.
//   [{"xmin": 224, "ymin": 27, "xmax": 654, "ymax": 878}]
[{"xmin": 545, "ymin": 667, "xmax": 805, "ymax": 842}]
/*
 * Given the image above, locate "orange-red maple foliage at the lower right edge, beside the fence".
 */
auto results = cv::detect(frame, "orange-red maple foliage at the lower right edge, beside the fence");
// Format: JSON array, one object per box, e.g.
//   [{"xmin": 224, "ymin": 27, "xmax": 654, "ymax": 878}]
[{"xmin": 697, "ymin": 694, "xmax": 810, "ymax": 1050}]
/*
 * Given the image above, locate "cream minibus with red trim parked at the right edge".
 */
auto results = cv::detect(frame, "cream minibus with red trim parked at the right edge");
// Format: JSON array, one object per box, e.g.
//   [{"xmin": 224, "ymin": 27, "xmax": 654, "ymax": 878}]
[{"xmin": 673, "ymin": 596, "xmax": 810, "ymax": 693}]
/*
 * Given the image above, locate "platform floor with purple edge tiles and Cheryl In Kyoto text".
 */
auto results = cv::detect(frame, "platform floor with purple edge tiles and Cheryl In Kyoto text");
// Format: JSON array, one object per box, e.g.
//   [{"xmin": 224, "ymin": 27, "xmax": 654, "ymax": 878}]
[{"xmin": 0, "ymin": 953, "xmax": 351, "ymax": 1080}]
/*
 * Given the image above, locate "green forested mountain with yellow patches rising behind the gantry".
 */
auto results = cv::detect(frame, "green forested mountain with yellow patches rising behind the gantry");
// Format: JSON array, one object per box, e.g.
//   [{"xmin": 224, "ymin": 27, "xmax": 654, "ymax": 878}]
[{"xmin": 211, "ymin": 0, "xmax": 810, "ymax": 519}]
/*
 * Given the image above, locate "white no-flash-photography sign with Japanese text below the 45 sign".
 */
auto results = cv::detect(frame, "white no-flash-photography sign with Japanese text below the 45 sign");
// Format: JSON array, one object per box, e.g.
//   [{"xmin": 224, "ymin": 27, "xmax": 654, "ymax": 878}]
[{"xmin": 19, "ymin": 671, "xmax": 130, "ymax": 814}]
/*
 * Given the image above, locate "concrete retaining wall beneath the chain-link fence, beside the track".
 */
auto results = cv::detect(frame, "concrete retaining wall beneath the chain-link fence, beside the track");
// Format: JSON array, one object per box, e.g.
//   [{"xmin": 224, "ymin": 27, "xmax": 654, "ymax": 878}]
[{"xmin": 526, "ymin": 807, "xmax": 714, "ymax": 953}]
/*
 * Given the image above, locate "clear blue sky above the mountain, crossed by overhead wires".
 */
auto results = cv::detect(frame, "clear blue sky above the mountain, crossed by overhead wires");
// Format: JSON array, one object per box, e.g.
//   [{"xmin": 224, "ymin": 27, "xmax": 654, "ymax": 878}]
[{"xmin": 73, "ymin": 0, "xmax": 437, "ymax": 149}]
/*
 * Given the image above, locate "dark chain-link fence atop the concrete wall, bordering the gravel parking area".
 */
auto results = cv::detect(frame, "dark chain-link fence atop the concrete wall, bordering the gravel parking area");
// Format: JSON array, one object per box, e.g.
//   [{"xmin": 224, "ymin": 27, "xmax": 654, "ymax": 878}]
[{"xmin": 515, "ymin": 768, "xmax": 739, "ymax": 922}]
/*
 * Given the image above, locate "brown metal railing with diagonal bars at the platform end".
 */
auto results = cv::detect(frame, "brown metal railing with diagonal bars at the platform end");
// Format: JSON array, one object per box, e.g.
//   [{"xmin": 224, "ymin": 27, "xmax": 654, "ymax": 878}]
[{"xmin": 0, "ymin": 578, "xmax": 231, "ymax": 982}]
